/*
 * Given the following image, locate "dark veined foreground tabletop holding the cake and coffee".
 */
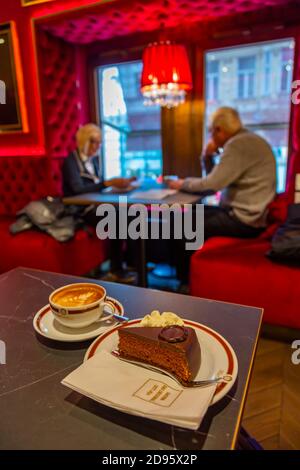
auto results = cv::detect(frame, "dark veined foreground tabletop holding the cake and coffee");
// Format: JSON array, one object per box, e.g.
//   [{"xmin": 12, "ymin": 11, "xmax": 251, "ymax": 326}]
[{"xmin": 0, "ymin": 268, "xmax": 262, "ymax": 450}]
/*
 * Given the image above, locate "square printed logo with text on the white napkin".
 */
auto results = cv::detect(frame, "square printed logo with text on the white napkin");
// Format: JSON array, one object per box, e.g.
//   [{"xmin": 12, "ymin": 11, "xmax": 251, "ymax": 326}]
[{"xmin": 133, "ymin": 379, "xmax": 182, "ymax": 408}]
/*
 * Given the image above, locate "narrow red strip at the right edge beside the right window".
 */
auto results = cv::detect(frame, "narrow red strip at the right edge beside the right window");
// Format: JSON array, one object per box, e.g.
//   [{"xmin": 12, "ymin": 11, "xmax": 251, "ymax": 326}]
[{"xmin": 287, "ymin": 35, "xmax": 300, "ymax": 202}]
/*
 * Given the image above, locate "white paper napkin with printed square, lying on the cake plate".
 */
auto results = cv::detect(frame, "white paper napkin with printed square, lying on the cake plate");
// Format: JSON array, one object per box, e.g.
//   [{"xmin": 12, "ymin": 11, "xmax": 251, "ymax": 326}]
[{"xmin": 62, "ymin": 351, "xmax": 216, "ymax": 430}]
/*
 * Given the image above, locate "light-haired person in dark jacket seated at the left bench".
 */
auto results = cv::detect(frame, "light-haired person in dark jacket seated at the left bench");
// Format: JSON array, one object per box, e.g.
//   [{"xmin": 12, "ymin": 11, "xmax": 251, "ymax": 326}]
[{"xmin": 62, "ymin": 124, "xmax": 135, "ymax": 281}]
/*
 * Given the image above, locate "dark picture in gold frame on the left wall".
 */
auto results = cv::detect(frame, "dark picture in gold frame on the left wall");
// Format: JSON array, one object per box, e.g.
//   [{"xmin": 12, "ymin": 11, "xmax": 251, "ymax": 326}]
[{"xmin": 0, "ymin": 22, "xmax": 28, "ymax": 133}]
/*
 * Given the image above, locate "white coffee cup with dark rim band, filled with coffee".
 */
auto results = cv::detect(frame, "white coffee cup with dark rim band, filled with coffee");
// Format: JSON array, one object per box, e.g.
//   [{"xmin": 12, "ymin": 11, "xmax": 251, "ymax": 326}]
[{"xmin": 49, "ymin": 282, "xmax": 116, "ymax": 328}]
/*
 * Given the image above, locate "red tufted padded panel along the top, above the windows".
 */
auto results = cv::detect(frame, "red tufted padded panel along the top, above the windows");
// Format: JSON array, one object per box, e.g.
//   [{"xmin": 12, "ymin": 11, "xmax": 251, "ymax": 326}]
[{"xmin": 39, "ymin": 0, "xmax": 298, "ymax": 44}]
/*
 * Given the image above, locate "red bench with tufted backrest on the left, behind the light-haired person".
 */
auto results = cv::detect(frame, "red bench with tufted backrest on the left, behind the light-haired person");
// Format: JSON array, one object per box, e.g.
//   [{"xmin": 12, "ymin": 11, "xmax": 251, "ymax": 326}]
[{"xmin": 0, "ymin": 157, "xmax": 107, "ymax": 275}]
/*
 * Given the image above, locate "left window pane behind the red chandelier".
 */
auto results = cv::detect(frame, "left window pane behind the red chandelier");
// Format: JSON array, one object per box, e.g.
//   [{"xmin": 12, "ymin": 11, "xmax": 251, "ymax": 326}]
[{"xmin": 97, "ymin": 61, "xmax": 162, "ymax": 178}]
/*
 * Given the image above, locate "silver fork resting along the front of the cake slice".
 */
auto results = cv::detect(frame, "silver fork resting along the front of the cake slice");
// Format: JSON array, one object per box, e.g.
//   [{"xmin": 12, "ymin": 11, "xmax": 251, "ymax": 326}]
[{"xmin": 111, "ymin": 350, "xmax": 232, "ymax": 388}]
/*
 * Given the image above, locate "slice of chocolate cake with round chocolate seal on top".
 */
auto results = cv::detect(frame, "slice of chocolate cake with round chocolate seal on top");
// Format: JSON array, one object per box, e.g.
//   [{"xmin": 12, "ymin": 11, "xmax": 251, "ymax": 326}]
[{"xmin": 118, "ymin": 325, "xmax": 201, "ymax": 382}]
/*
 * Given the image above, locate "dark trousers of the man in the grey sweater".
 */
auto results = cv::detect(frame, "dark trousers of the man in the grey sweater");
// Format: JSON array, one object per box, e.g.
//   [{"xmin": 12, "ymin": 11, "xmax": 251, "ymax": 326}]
[{"xmin": 173, "ymin": 206, "xmax": 264, "ymax": 282}]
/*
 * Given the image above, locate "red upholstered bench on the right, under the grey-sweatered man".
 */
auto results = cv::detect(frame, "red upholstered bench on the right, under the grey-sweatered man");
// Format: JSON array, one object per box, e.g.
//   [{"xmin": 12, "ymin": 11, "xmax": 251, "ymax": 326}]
[{"xmin": 190, "ymin": 197, "xmax": 300, "ymax": 328}]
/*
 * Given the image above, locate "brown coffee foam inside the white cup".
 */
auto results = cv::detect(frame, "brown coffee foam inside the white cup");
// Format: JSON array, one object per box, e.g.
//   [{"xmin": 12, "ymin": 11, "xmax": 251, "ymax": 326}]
[{"xmin": 52, "ymin": 286, "xmax": 104, "ymax": 307}]
